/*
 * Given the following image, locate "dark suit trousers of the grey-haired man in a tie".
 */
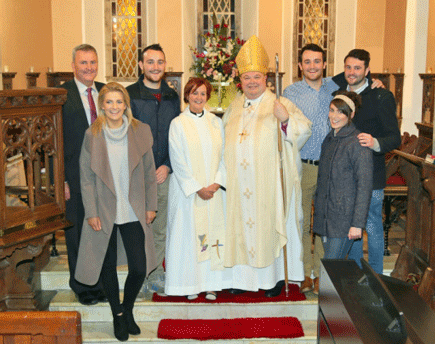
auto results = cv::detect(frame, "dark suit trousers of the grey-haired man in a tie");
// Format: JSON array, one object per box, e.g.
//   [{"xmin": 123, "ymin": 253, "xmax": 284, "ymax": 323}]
[{"xmin": 65, "ymin": 192, "xmax": 101, "ymax": 294}]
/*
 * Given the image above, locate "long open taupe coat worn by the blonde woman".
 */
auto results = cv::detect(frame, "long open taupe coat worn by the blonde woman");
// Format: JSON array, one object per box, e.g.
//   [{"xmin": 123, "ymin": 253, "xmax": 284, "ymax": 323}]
[{"xmin": 75, "ymin": 120, "xmax": 157, "ymax": 285}]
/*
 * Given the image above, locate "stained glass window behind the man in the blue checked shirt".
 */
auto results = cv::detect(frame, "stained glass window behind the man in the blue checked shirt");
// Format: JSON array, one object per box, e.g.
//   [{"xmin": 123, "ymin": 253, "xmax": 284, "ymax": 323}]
[{"xmin": 293, "ymin": 0, "xmax": 336, "ymax": 81}]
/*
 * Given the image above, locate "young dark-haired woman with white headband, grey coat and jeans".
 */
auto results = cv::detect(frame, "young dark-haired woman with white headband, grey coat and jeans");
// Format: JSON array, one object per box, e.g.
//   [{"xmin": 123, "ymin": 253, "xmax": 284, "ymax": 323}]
[{"xmin": 313, "ymin": 91, "xmax": 373, "ymax": 259}]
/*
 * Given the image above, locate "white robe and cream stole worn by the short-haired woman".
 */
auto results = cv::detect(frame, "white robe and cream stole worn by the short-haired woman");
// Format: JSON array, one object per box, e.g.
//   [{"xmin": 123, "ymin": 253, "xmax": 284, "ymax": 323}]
[{"xmin": 165, "ymin": 108, "xmax": 231, "ymax": 295}]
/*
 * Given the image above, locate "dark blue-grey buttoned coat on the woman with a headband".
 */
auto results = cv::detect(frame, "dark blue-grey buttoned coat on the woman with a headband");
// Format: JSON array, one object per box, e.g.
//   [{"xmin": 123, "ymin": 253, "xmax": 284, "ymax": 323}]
[{"xmin": 313, "ymin": 123, "xmax": 373, "ymax": 238}]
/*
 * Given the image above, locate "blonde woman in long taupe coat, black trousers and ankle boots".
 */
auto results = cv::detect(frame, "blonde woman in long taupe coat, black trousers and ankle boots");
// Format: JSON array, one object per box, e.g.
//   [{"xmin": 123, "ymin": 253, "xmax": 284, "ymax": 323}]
[{"xmin": 75, "ymin": 82, "xmax": 157, "ymax": 341}]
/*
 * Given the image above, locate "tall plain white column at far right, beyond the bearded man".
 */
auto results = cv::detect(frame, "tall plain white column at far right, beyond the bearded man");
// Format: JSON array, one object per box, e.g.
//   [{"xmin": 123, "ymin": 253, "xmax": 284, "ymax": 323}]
[{"xmin": 402, "ymin": 0, "xmax": 429, "ymax": 134}]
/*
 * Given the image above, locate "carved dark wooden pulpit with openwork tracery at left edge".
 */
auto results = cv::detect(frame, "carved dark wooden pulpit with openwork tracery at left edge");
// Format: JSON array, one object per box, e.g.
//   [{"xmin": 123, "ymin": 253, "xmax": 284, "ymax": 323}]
[{"xmin": 0, "ymin": 89, "xmax": 69, "ymax": 310}]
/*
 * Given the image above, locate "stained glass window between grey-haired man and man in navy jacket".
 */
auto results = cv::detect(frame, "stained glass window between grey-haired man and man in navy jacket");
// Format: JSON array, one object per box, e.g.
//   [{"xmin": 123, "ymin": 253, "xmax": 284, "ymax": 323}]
[{"xmin": 106, "ymin": 0, "xmax": 145, "ymax": 81}]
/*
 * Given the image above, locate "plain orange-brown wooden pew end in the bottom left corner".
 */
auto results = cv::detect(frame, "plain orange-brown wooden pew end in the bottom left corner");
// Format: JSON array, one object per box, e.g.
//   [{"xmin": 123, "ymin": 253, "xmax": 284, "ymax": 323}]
[{"xmin": 0, "ymin": 311, "xmax": 82, "ymax": 344}]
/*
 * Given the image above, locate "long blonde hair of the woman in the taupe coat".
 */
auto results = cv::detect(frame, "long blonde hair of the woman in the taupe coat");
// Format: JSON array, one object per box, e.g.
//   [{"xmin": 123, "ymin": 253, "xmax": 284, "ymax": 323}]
[{"xmin": 91, "ymin": 82, "xmax": 138, "ymax": 136}]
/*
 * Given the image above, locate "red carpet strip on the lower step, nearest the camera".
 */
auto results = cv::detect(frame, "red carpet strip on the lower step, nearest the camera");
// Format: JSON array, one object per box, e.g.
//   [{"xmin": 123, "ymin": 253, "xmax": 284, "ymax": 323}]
[{"xmin": 157, "ymin": 317, "xmax": 304, "ymax": 340}]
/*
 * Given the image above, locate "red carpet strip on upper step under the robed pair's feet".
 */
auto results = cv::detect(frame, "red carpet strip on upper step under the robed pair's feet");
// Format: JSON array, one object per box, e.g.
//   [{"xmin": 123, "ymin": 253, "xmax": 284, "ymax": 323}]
[{"xmin": 153, "ymin": 284, "xmax": 306, "ymax": 303}]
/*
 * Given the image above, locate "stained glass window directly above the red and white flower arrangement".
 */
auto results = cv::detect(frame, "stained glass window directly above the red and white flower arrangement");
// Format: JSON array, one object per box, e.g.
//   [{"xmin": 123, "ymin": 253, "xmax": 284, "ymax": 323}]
[{"xmin": 198, "ymin": 0, "xmax": 241, "ymax": 38}]
